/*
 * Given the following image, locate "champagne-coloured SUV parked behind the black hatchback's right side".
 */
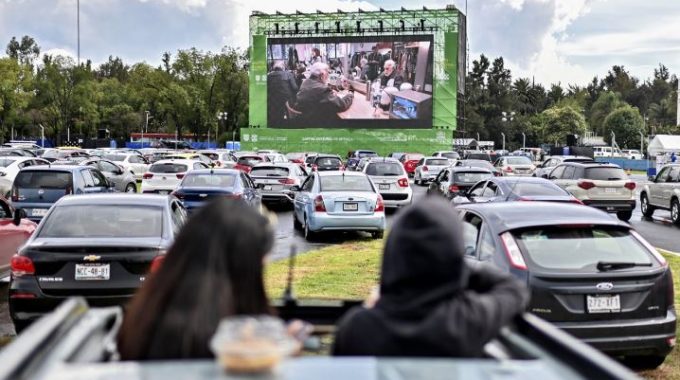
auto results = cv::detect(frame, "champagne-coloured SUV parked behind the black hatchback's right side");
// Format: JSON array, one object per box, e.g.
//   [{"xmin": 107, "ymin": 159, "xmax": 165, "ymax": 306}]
[{"xmin": 549, "ymin": 162, "xmax": 635, "ymax": 221}]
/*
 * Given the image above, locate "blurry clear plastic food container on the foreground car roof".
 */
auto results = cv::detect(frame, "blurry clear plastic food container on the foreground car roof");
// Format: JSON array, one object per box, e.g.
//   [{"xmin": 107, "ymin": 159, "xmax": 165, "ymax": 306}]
[{"xmin": 210, "ymin": 315, "xmax": 299, "ymax": 373}]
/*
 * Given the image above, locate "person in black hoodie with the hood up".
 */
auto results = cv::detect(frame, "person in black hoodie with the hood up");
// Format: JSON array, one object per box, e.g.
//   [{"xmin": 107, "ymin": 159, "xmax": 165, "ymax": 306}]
[{"xmin": 333, "ymin": 198, "xmax": 528, "ymax": 357}]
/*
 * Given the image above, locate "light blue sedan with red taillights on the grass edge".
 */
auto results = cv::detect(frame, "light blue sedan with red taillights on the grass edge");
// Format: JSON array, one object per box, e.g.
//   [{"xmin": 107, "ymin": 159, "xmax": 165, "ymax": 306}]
[{"xmin": 293, "ymin": 172, "xmax": 385, "ymax": 240}]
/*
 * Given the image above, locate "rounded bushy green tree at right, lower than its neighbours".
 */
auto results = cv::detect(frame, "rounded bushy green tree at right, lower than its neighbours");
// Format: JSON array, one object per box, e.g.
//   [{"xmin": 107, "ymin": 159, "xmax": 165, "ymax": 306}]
[{"xmin": 604, "ymin": 104, "xmax": 645, "ymax": 148}]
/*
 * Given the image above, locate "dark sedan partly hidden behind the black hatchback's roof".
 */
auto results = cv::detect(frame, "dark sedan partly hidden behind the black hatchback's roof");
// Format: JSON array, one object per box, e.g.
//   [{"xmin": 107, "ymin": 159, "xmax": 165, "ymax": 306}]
[{"xmin": 453, "ymin": 177, "xmax": 583, "ymax": 204}]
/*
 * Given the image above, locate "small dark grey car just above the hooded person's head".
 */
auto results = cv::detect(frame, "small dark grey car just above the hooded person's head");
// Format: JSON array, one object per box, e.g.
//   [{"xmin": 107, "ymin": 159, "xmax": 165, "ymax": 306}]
[{"xmin": 427, "ymin": 166, "xmax": 494, "ymax": 200}]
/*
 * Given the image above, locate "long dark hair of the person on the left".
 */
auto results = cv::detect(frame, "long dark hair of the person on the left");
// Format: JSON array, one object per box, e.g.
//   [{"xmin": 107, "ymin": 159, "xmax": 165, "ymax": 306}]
[{"xmin": 118, "ymin": 199, "xmax": 274, "ymax": 360}]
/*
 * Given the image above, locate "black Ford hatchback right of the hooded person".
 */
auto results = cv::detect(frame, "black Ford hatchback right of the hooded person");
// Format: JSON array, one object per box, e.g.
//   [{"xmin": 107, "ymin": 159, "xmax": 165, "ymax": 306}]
[{"xmin": 458, "ymin": 202, "xmax": 676, "ymax": 368}]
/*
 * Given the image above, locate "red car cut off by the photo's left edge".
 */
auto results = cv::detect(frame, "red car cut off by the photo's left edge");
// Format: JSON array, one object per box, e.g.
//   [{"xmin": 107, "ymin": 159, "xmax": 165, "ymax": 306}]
[{"xmin": 0, "ymin": 197, "xmax": 37, "ymax": 278}]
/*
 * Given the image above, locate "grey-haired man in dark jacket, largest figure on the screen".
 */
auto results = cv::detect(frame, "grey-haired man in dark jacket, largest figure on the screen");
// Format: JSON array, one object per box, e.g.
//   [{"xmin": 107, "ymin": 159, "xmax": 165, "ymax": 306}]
[{"xmin": 294, "ymin": 62, "xmax": 354, "ymax": 122}]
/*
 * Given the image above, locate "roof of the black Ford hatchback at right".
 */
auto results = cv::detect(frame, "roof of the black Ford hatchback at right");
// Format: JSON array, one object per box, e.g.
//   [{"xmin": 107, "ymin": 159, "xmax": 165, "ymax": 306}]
[{"xmin": 457, "ymin": 202, "xmax": 630, "ymax": 232}]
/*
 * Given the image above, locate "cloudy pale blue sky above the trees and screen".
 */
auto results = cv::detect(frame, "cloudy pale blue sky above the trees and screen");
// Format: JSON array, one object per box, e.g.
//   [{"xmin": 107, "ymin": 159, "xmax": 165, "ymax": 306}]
[{"xmin": 0, "ymin": 0, "xmax": 680, "ymax": 85}]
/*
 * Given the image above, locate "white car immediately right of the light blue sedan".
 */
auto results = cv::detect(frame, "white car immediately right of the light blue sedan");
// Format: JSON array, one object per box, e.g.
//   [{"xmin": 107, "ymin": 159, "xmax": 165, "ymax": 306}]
[{"xmin": 362, "ymin": 158, "xmax": 413, "ymax": 208}]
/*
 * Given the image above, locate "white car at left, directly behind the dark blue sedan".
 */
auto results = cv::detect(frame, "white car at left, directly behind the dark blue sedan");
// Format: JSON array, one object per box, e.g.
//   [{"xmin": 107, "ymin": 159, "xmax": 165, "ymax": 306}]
[{"xmin": 142, "ymin": 159, "xmax": 210, "ymax": 194}]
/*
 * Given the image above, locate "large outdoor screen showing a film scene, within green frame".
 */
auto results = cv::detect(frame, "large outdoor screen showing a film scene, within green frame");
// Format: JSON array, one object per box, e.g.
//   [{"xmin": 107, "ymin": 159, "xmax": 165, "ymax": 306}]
[{"xmin": 267, "ymin": 35, "xmax": 433, "ymax": 128}]
